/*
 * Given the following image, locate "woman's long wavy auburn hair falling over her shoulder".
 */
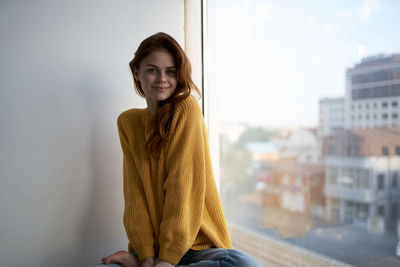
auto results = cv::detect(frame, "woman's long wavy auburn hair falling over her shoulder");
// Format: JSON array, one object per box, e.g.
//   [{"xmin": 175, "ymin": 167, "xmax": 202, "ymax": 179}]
[{"xmin": 129, "ymin": 32, "xmax": 201, "ymax": 157}]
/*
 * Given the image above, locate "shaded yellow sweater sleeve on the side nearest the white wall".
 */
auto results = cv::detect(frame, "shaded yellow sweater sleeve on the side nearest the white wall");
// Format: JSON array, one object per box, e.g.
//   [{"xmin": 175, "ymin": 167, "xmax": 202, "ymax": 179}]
[{"xmin": 117, "ymin": 116, "xmax": 155, "ymax": 260}]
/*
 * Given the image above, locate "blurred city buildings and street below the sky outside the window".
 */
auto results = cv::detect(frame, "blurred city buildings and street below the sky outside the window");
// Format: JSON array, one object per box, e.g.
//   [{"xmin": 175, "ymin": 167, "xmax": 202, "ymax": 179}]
[{"xmin": 220, "ymin": 54, "xmax": 400, "ymax": 266}]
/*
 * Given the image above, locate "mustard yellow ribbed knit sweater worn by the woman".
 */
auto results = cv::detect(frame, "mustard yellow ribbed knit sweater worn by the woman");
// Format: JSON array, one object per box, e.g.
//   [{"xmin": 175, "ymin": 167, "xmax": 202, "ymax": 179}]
[{"xmin": 118, "ymin": 96, "xmax": 231, "ymax": 265}]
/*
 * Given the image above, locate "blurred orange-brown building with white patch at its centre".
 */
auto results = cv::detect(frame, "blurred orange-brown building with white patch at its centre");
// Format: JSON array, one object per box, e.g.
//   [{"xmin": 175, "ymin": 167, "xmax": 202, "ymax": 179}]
[{"xmin": 263, "ymin": 161, "xmax": 325, "ymax": 237}]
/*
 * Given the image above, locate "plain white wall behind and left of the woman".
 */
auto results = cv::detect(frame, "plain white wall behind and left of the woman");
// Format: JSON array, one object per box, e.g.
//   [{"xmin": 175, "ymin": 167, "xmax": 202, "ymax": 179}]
[{"xmin": 0, "ymin": 0, "xmax": 184, "ymax": 267}]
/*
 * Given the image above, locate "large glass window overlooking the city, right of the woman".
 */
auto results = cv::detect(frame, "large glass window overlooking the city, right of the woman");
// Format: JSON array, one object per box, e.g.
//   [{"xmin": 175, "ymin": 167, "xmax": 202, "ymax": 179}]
[{"xmin": 204, "ymin": 0, "xmax": 400, "ymax": 266}]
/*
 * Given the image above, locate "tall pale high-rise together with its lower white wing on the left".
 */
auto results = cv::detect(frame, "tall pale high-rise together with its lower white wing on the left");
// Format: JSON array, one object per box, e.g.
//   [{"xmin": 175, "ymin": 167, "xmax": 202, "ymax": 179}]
[{"xmin": 319, "ymin": 54, "xmax": 400, "ymax": 137}]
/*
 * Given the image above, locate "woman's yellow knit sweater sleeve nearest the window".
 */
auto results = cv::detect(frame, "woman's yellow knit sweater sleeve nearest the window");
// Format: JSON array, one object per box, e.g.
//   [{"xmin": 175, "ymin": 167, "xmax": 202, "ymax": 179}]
[{"xmin": 158, "ymin": 99, "xmax": 206, "ymax": 265}]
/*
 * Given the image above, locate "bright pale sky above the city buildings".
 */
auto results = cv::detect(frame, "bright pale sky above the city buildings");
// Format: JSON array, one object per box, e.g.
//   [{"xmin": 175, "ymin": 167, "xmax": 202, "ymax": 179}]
[{"xmin": 208, "ymin": 0, "xmax": 400, "ymax": 128}]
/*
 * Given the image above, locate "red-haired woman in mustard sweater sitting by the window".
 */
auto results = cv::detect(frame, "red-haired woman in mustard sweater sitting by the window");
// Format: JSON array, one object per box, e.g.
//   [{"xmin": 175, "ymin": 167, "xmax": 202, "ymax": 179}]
[{"xmin": 98, "ymin": 33, "xmax": 257, "ymax": 267}]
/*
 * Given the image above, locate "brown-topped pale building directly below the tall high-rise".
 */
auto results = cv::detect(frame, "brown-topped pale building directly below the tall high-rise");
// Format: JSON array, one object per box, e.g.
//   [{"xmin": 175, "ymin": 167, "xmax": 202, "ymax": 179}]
[{"xmin": 323, "ymin": 127, "xmax": 400, "ymax": 233}]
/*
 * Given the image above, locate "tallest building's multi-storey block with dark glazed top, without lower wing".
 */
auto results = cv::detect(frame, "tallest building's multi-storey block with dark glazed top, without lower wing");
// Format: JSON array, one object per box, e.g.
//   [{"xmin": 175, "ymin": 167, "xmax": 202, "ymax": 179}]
[{"xmin": 345, "ymin": 54, "xmax": 400, "ymax": 129}]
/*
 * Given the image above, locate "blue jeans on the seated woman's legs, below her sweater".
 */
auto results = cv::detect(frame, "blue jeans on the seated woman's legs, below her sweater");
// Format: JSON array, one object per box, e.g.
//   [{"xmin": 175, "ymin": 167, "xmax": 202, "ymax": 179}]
[{"xmin": 93, "ymin": 248, "xmax": 259, "ymax": 267}]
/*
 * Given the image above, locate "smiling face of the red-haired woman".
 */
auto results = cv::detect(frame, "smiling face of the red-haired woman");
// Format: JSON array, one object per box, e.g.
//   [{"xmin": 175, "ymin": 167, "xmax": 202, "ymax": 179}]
[{"xmin": 134, "ymin": 50, "xmax": 178, "ymax": 111}]
